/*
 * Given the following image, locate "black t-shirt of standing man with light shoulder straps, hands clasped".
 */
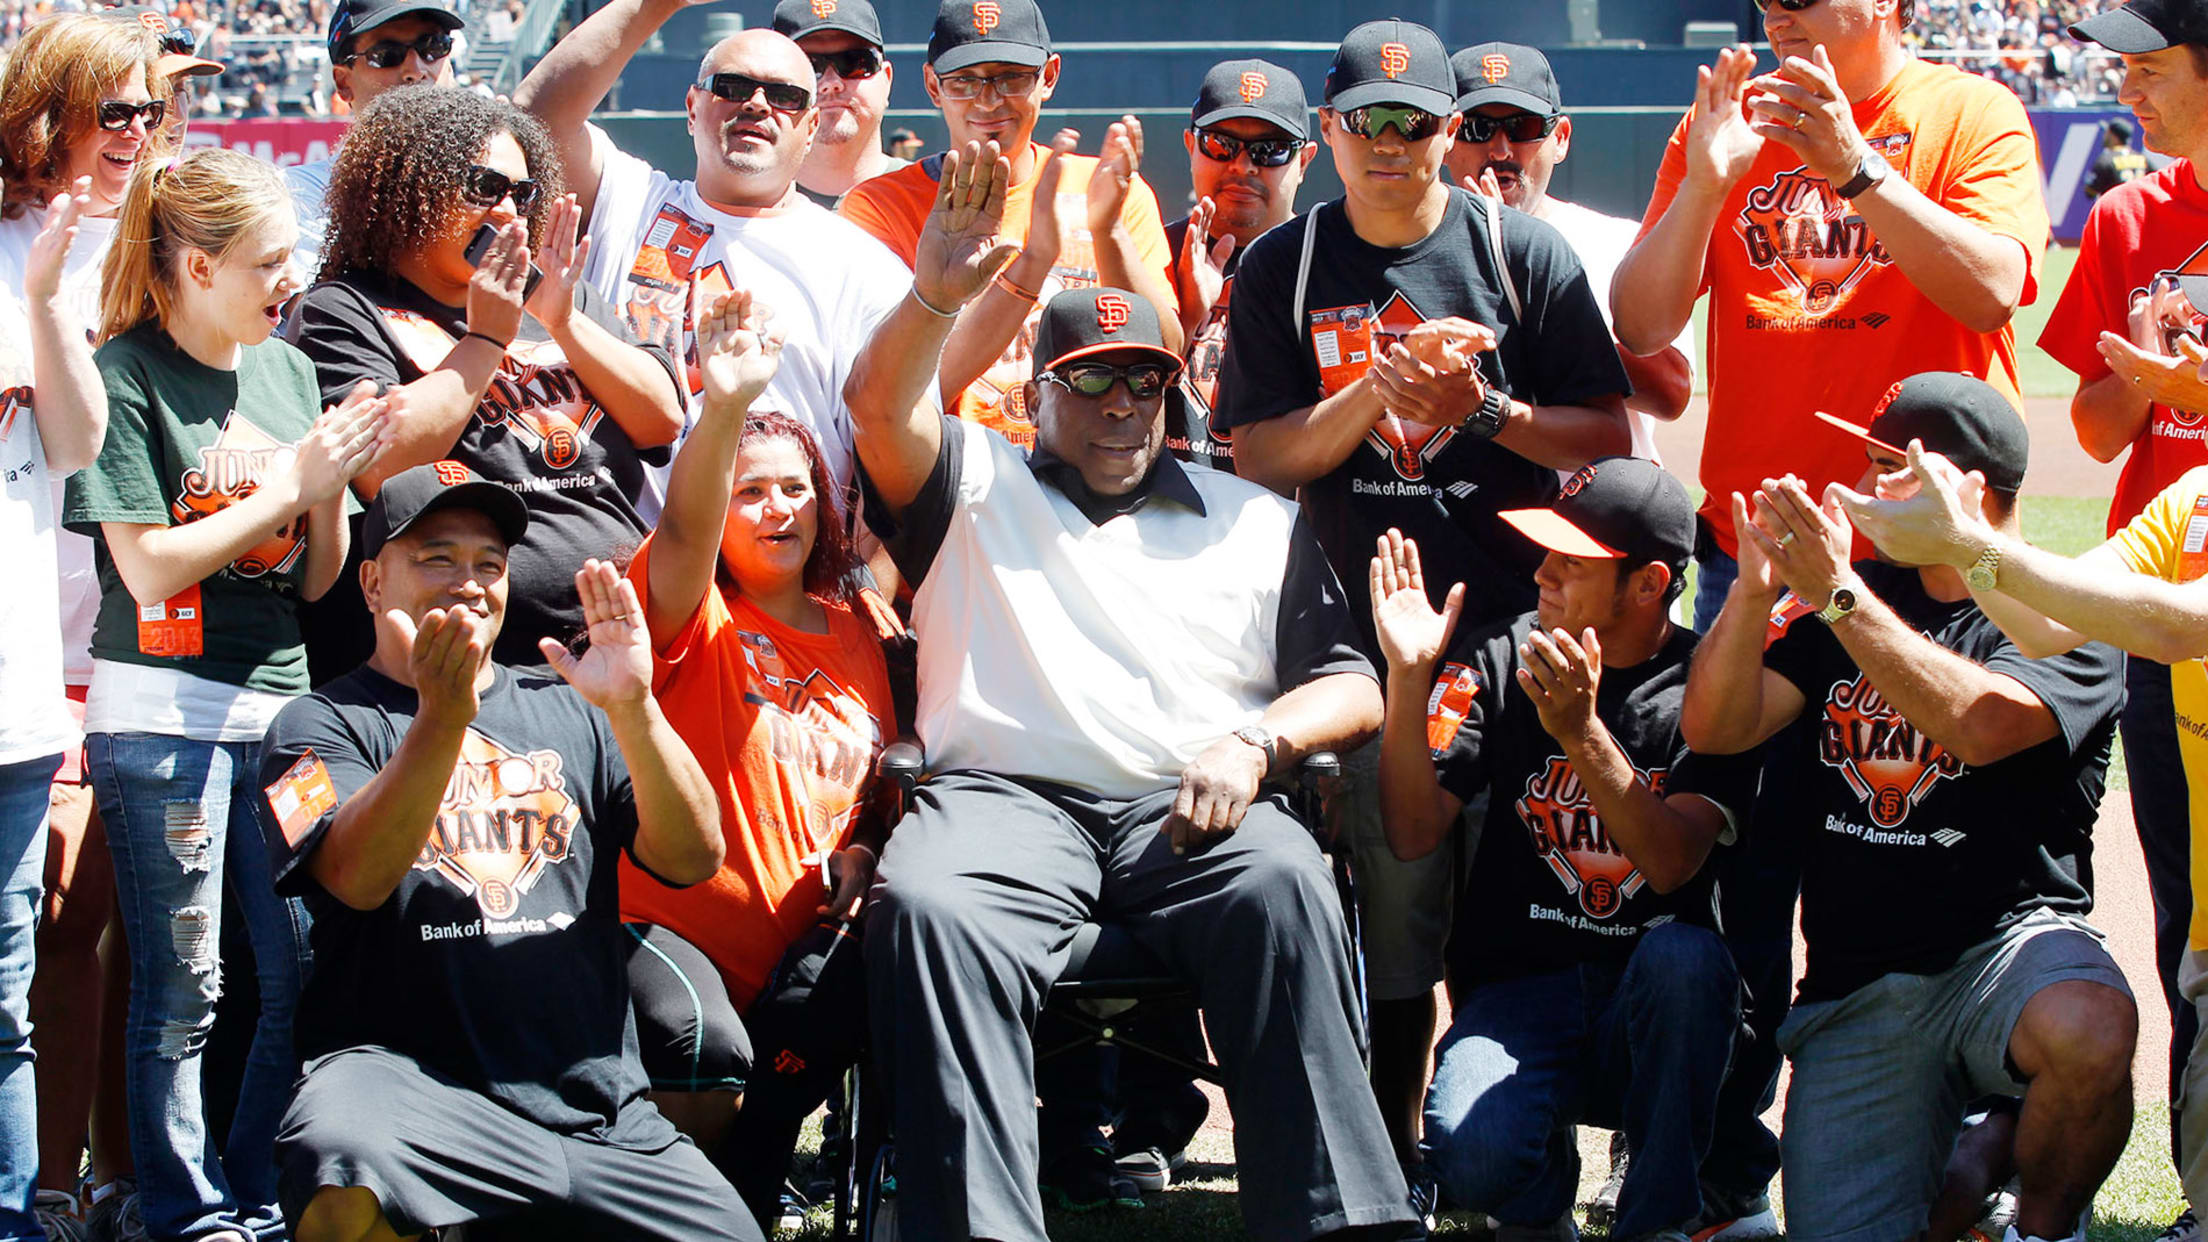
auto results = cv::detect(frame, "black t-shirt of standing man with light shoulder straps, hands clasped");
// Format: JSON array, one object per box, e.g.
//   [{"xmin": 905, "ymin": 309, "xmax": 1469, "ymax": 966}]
[{"xmin": 1214, "ymin": 190, "xmax": 1632, "ymax": 659}]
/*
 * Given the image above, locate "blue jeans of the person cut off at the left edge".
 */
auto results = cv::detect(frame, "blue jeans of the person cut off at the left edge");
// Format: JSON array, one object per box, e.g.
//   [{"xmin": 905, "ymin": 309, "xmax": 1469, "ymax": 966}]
[{"xmin": 0, "ymin": 754, "xmax": 62, "ymax": 1242}]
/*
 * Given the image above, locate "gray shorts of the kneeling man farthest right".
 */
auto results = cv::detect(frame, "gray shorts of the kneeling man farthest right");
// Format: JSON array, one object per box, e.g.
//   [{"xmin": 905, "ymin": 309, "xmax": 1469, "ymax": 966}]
[{"xmin": 1780, "ymin": 897, "xmax": 2131, "ymax": 1242}]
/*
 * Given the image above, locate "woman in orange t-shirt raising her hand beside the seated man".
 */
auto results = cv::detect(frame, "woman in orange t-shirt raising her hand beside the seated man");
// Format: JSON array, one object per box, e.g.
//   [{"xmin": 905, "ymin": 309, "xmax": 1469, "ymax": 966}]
[{"xmin": 620, "ymin": 292, "xmax": 903, "ymax": 1224}]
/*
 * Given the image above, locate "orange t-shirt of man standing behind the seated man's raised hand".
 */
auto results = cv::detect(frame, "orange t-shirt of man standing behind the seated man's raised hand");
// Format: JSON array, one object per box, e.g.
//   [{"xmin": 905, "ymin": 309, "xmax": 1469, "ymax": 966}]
[{"xmin": 837, "ymin": 144, "xmax": 1172, "ymax": 449}]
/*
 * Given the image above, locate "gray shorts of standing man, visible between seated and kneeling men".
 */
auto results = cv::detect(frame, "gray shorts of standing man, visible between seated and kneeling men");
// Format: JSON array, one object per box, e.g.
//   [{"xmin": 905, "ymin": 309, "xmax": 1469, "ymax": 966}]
[{"xmin": 1338, "ymin": 740, "xmax": 1486, "ymax": 1001}]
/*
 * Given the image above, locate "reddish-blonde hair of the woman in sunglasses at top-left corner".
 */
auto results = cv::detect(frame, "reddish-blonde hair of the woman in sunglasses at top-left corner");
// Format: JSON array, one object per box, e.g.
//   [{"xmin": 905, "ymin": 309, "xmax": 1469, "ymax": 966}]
[{"xmin": 0, "ymin": 13, "xmax": 161, "ymax": 219}]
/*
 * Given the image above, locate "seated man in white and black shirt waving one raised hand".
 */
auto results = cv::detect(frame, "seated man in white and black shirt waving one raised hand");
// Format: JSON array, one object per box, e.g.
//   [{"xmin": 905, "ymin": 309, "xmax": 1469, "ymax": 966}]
[{"xmin": 846, "ymin": 148, "xmax": 1415, "ymax": 1242}]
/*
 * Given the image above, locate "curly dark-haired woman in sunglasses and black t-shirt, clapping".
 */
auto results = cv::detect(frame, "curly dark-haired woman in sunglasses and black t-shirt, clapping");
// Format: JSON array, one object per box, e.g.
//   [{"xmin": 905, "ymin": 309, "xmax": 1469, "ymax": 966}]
[{"xmin": 291, "ymin": 86, "xmax": 682, "ymax": 678}]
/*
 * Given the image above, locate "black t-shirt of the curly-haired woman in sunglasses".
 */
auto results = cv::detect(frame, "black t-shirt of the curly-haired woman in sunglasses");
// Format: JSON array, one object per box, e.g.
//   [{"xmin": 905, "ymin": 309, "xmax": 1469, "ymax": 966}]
[{"xmin": 289, "ymin": 272, "xmax": 682, "ymax": 683}]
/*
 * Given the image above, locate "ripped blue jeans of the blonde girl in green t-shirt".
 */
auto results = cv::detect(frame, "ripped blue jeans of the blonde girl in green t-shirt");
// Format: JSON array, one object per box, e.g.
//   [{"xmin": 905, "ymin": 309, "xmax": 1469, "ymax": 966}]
[{"xmin": 84, "ymin": 734, "xmax": 309, "ymax": 1240}]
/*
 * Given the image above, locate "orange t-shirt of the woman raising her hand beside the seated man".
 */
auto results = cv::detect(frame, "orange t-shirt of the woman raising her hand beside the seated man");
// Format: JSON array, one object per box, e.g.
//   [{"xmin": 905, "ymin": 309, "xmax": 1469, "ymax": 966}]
[{"xmin": 620, "ymin": 537, "xmax": 894, "ymax": 1010}]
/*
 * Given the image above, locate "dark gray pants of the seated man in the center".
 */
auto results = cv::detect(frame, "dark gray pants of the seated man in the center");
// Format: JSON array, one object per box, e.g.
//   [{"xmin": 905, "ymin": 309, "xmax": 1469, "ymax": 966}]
[{"xmin": 866, "ymin": 771, "xmax": 1411, "ymax": 1242}]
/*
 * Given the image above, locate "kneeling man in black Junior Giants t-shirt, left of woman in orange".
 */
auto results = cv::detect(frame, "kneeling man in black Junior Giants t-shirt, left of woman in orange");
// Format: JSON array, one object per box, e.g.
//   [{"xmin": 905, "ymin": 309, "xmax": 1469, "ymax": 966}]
[{"xmin": 261, "ymin": 462, "xmax": 760, "ymax": 1242}]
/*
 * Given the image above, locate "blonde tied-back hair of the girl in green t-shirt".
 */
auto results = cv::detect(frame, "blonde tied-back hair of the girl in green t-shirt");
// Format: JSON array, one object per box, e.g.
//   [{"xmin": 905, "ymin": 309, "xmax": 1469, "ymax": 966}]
[{"xmin": 99, "ymin": 146, "xmax": 291, "ymax": 340}]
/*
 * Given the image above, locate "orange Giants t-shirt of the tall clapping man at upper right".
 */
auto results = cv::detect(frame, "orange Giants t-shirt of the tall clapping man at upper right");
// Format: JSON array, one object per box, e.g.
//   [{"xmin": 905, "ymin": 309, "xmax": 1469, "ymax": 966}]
[{"xmin": 1641, "ymin": 60, "xmax": 2047, "ymax": 552}]
